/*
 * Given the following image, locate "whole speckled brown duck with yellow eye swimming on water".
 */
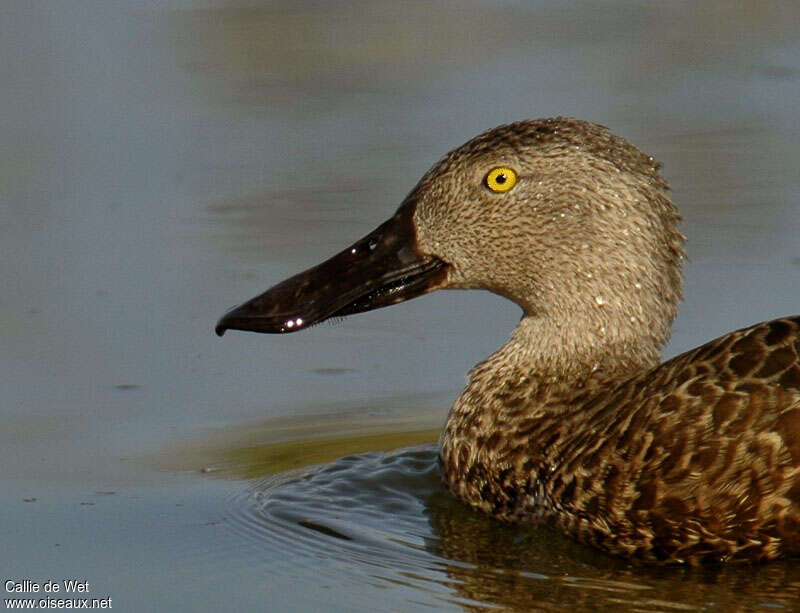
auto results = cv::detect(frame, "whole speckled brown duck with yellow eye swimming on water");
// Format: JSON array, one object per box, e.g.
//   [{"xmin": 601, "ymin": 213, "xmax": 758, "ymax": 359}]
[{"xmin": 216, "ymin": 117, "xmax": 800, "ymax": 565}]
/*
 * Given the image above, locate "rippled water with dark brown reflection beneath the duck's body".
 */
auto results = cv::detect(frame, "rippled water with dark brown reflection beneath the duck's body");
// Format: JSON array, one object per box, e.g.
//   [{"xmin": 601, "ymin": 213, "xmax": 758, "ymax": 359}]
[{"xmin": 228, "ymin": 445, "xmax": 800, "ymax": 611}]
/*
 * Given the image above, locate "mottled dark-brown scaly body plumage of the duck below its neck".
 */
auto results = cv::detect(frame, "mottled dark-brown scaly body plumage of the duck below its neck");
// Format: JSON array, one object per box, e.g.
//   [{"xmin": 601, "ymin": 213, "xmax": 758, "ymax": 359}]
[{"xmin": 441, "ymin": 317, "xmax": 800, "ymax": 562}]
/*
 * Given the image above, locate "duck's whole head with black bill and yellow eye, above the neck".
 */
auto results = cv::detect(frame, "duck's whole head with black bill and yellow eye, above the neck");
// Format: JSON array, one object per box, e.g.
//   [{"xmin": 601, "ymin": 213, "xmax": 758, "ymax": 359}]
[{"xmin": 216, "ymin": 118, "xmax": 683, "ymax": 360}]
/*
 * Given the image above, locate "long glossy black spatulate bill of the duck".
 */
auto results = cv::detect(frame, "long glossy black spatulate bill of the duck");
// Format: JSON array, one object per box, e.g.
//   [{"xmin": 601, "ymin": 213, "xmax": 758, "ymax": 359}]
[{"xmin": 216, "ymin": 202, "xmax": 447, "ymax": 336}]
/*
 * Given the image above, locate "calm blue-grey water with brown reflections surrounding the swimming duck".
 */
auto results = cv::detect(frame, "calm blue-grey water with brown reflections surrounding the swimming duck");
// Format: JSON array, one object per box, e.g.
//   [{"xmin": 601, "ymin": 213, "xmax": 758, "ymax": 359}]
[{"xmin": 0, "ymin": 0, "xmax": 800, "ymax": 611}]
